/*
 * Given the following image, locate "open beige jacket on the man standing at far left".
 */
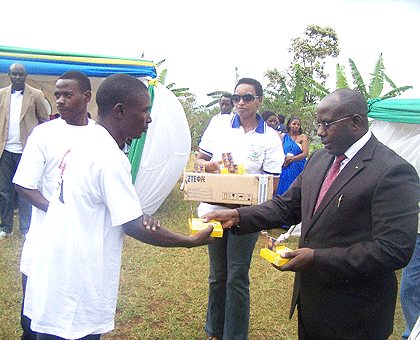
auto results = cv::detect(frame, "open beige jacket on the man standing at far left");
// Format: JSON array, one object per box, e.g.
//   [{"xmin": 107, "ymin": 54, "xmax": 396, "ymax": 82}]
[{"xmin": 0, "ymin": 84, "xmax": 50, "ymax": 157}]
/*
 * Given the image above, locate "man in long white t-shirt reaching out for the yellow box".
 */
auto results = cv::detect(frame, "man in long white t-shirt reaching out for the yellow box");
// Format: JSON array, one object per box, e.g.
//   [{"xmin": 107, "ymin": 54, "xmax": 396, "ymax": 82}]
[{"xmin": 24, "ymin": 74, "xmax": 213, "ymax": 340}]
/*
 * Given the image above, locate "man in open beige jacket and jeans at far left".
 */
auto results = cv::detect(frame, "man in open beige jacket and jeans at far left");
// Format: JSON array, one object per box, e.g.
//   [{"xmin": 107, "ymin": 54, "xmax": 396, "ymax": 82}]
[{"xmin": 0, "ymin": 63, "xmax": 49, "ymax": 240}]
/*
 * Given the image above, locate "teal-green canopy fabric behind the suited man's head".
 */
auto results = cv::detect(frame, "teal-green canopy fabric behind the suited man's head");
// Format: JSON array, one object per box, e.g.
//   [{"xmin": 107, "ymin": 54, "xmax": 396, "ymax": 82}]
[{"xmin": 368, "ymin": 99, "xmax": 420, "ymax": 124}]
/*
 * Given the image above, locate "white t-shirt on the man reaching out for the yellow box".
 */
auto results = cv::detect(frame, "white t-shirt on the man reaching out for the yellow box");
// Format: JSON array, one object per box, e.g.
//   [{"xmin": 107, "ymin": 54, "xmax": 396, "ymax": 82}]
[{"xmin": 24, "ymin": 125, "xmax": 142, "ymax": 339}]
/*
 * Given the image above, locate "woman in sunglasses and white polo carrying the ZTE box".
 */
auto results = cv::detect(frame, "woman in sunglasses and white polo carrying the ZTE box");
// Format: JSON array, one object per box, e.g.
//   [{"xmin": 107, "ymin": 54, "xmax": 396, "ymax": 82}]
[{"xmin": 195, "ymin": 78, "xmax": 284, "ymax": 340}]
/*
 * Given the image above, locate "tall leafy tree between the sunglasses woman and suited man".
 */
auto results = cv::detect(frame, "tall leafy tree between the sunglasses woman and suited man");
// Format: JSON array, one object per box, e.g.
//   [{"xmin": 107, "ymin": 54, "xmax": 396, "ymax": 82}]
[{"xmin": 261, "ymin": 25, "xmax": 340, "ymax": 143}]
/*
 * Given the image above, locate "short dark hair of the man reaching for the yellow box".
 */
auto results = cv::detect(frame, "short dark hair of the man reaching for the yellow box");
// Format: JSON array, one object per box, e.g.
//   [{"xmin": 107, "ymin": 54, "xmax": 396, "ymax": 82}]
[{"xmin": 96, "ymin": 73, "xmax": 148, "ymax": 115}]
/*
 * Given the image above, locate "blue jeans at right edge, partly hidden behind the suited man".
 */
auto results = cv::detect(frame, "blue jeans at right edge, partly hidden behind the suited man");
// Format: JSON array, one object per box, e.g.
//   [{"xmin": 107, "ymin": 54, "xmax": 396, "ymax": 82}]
[{"xmin": 400, "ymin": 234, "xmax": 420, "ymax": 339}]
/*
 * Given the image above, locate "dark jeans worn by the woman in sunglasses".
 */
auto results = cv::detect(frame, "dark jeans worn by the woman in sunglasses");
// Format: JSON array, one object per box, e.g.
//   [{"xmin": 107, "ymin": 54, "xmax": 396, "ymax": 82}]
[{"xmin": 205, "ymin": 229, "xmax": 259, "ymax": 340}]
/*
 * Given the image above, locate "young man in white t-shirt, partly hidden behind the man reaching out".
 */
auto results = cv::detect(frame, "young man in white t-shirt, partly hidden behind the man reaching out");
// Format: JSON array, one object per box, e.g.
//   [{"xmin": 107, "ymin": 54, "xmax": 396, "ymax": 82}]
[{"xmin": 13, "ymin": 71, "xmax": 95, "ymax": 340}]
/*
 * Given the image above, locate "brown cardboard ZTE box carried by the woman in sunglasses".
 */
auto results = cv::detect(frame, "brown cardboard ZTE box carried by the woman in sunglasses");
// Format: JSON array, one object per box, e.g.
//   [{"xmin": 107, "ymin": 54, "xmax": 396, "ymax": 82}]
[{"xmin": 183, "ymin": 172, "xmax": 273, "ymax": 205}]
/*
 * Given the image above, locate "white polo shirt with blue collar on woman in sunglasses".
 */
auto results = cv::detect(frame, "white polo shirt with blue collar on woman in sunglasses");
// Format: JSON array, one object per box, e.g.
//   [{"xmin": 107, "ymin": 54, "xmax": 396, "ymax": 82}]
[{"xmin": 198, "ymin": 114, "xmax": 284, "ymax": 216}]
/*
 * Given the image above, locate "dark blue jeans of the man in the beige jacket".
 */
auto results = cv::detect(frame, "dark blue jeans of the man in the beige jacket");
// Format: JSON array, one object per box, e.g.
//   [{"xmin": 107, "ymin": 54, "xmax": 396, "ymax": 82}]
[{"xmin": 0, "ymin": 150, "xmax": 32, "ymax": 234}]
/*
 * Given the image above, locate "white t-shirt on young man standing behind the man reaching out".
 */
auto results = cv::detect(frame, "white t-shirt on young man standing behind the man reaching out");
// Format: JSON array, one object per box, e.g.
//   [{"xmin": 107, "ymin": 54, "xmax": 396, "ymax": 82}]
[{"xmin": 13, "ymin": 118, "xmax": 95, "ymax": 275}]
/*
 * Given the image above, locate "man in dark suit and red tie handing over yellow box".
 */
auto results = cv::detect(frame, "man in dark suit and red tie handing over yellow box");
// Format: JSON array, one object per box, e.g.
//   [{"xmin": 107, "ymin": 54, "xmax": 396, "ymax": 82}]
[{"xmin": 206, "ymin": 89, "xmax": 420, "ymax": 340}]
